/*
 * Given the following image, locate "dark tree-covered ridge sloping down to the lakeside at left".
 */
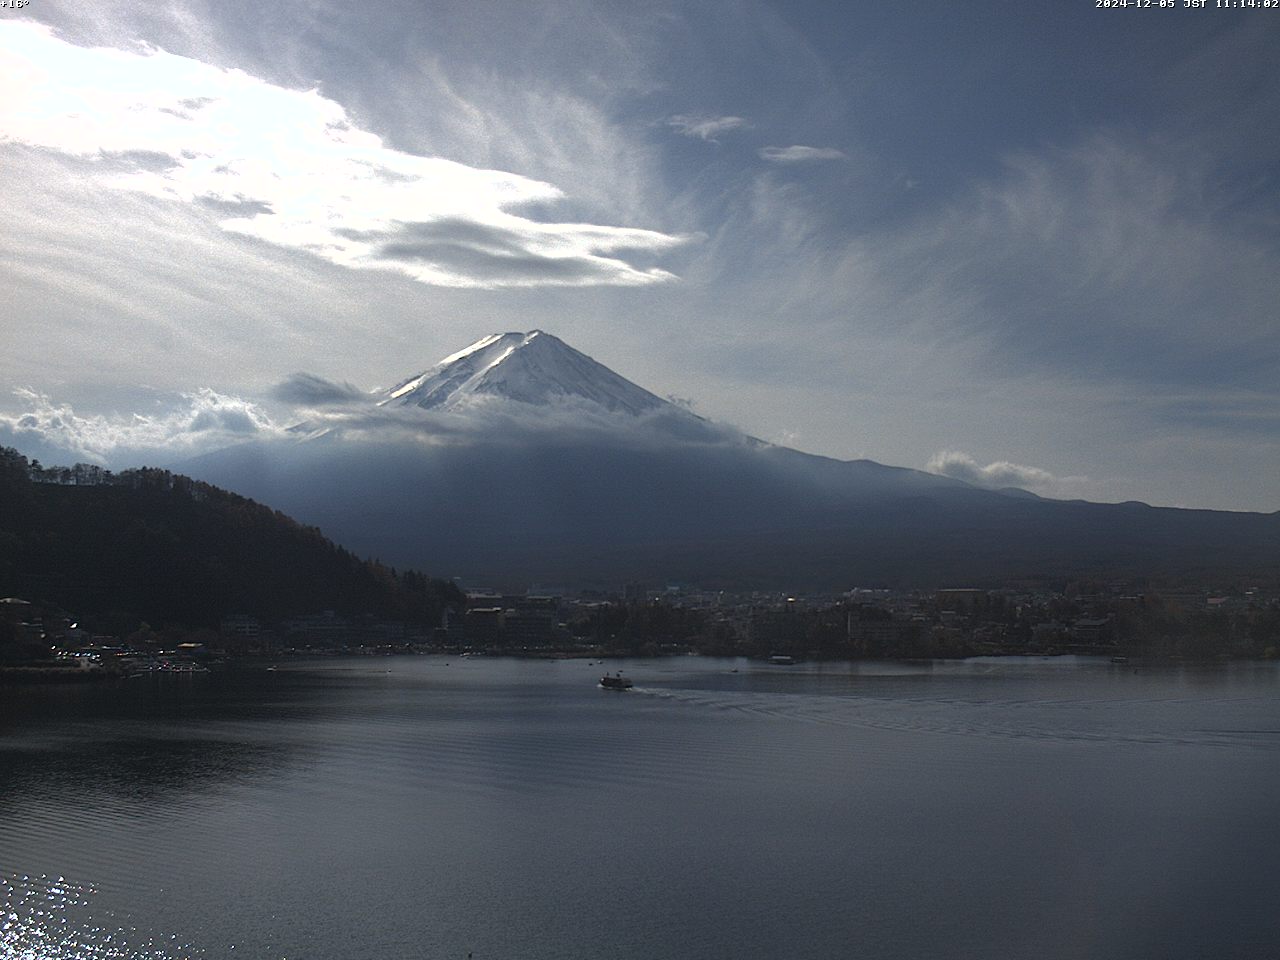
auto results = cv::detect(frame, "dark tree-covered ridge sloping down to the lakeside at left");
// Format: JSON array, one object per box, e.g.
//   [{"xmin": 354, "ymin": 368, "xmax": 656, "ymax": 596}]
[{"xmin": 0, "ymin": 448, "xmax": 462, "ymax": 631}]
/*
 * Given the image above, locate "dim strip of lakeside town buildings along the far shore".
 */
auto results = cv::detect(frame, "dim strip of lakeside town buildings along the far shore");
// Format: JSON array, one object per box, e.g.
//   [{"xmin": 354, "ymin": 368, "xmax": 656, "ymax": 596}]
[{"xmin": 0, "ymin": 582, "xmax": 1280, "ymax": 680}]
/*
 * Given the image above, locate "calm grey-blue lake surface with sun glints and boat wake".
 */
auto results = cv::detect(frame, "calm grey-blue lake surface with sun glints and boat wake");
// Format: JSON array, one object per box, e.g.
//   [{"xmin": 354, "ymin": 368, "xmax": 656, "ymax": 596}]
[{"xmin": 0, "ymin": 657, "xmax": 1280, "ymax": 960}]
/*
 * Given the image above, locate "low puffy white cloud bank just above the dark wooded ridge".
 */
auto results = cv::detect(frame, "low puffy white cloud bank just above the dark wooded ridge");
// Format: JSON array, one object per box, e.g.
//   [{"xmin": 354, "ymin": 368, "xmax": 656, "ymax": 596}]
[{"xmin": 0, "ymin": 387, "xmax": 284, "ymax": 466}]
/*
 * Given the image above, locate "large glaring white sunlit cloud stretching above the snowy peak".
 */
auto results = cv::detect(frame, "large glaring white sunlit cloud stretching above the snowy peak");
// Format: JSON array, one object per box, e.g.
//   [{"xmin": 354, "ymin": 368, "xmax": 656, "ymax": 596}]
[{"xmin": 0, "ymin": 22, "xmax": 684, "ymax": 287}]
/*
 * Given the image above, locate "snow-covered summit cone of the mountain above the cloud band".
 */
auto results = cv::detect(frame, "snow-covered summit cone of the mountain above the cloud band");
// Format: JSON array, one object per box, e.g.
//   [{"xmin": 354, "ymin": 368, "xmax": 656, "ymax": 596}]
[{"xmin": 379, "ymin": 330, "xmax": 667, "ymax": 415}]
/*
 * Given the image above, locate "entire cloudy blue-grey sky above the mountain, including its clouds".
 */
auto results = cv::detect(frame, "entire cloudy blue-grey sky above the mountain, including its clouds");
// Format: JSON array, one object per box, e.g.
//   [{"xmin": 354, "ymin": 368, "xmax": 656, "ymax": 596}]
[{"xmin": 0, "ymin": 0, "xmax": 1280, "ymax": 511}]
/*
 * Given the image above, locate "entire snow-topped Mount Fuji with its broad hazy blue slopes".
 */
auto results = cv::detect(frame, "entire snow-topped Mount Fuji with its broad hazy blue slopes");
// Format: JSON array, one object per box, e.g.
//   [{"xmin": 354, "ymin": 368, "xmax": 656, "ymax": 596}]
[{"xmin": 183, "ymin": 330, "xmax": 1280, "ymax": 589}]
